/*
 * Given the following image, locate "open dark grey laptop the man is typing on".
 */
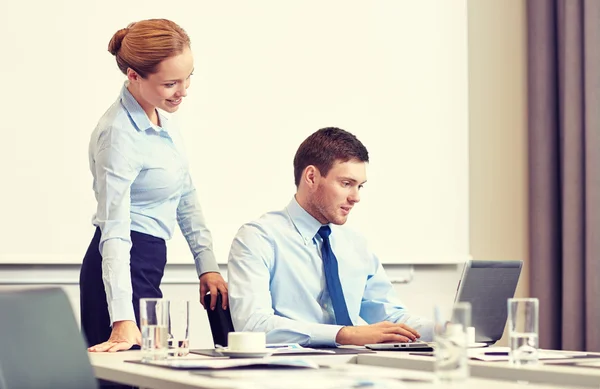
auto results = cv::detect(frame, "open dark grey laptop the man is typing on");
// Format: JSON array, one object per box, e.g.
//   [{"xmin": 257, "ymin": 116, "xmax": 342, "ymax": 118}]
[{"xmin": 365, "ymin": 260, "xmax": 523, "ymax": 351}]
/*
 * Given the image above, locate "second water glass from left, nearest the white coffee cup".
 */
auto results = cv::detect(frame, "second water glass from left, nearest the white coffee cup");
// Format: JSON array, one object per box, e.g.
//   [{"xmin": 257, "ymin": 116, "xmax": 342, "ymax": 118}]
[{"xmin": 168, "ymin": 300, "xmax": 190, "ymax": 357}]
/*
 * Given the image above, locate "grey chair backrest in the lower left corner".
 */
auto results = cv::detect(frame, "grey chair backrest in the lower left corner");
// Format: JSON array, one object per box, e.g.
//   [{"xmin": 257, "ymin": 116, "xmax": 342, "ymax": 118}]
[{"xmin": 0, "ymin": 288, "xmax": 98, "ymax": 389}]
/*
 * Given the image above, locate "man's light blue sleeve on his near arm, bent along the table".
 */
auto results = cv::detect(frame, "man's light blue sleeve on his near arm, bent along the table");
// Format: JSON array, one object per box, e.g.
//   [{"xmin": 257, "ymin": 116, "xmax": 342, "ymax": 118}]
[{"xmin": 227, "ymin": 225, "xmax": 342, "ymax": 346}]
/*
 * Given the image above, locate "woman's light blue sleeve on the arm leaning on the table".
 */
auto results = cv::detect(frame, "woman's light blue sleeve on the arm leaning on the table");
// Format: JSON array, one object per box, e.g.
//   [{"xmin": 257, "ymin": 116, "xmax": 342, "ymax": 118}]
[{"xmin": 94, "ymin": 131, "xmax": 140, "ymax": 324}]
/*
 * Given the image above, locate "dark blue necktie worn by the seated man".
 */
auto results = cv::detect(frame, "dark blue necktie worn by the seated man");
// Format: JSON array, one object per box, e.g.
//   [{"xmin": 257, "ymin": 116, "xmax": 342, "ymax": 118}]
[{"xmin": 319, "ymin": 226, "xmax": 352, "ymax": 326}]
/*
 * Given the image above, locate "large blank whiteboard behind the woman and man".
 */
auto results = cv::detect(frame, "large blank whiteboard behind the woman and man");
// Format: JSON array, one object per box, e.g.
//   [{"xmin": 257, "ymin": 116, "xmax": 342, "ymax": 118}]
[{"xmin": 0, "ymin": 0, "xmax": 469, "ymax": 264}]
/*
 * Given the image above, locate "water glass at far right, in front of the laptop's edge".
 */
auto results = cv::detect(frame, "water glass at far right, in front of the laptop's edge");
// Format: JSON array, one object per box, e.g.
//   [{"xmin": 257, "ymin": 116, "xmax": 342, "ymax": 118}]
[{"xmin": 508, "ymin": 298, "xmax": 539, "ymax": 366}]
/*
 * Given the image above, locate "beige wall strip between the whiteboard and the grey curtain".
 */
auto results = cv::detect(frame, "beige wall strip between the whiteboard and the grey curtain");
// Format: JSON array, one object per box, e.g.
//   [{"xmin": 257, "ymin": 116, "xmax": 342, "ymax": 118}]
[{"xmin": 468, "ymin": 0, "xmax": 529, "ymax": 342}]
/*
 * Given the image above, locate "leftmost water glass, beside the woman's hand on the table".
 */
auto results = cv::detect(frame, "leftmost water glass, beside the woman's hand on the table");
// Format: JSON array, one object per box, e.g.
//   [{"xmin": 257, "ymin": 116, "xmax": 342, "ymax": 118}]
[{"xmin": 140, "ymin": 298, "xmax": 169, "ymax": 362}]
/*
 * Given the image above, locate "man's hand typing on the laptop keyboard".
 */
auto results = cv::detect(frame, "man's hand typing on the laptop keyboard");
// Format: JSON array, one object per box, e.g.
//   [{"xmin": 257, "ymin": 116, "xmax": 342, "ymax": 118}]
[{"xmin": 335, "ymin": 321, "xmax": 421, "ymax": 346}]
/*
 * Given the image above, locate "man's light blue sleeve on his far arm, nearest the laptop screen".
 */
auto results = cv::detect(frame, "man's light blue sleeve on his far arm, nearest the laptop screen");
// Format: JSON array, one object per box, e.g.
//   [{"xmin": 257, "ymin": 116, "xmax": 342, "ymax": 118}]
[{"xmin": 360, "ymin": 255, "xmax": 433, "ymax": 341}]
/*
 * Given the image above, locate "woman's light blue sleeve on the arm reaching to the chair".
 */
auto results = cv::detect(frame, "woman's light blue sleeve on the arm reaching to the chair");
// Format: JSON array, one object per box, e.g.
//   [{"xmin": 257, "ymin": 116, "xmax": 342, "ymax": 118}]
[{"xmin": 177, "ymin": 173, "xmax": 219, "ymax": 276}]
